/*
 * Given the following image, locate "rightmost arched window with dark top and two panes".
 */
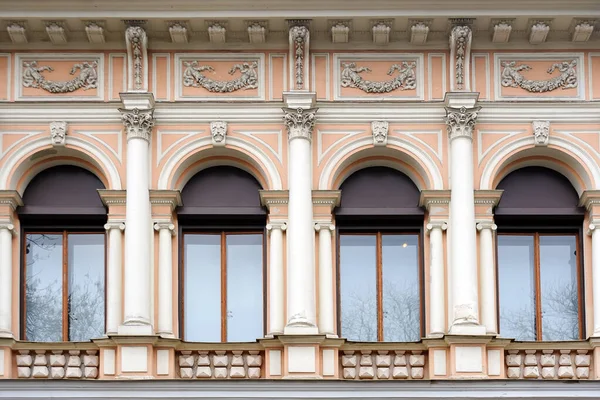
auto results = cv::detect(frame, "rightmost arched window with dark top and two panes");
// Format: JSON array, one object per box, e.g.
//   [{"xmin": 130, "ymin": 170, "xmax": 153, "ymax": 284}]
[{"xmin": 495, "ymin": 167, "xmax": 584, "ymax": 340}]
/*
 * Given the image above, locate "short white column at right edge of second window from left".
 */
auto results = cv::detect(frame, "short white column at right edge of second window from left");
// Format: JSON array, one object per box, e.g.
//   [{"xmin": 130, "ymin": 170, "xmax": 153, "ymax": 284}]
[{"xmin": 267, "ymin": 221, "xmax": 287, "ymax": 337}]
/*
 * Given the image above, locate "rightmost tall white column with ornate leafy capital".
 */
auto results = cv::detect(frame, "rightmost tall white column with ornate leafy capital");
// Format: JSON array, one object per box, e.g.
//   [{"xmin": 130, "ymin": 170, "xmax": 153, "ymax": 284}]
[{"xmin": 446, "ymin": 93, "xmax": 485, "ymax": 335}]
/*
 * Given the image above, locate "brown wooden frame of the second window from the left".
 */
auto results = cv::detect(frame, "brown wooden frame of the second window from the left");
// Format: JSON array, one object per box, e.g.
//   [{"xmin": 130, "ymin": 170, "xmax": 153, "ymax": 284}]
[{"xmin": 179, "ymin": 228, "xmax": 267, "ymax": 343}]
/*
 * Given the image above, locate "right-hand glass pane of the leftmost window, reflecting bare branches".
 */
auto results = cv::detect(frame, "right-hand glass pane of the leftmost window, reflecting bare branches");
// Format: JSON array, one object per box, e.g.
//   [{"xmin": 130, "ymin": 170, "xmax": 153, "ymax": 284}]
[{"xmin": 67, "ymin": 234, "xmax": 104, "ymax": 342}]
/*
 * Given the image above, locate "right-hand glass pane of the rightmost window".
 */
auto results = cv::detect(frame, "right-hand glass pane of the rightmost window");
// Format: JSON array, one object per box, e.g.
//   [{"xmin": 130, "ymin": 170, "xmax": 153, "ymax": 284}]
[{"xmin": 540, "ymin": 235, "xmax": 579, "ymax": 340}]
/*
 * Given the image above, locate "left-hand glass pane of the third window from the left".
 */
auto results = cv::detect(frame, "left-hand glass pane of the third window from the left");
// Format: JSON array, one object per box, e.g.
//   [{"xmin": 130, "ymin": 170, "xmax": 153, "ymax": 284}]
[{"xmin": 340, "ymin": 235, "xmax": 377, "ymax": 342}]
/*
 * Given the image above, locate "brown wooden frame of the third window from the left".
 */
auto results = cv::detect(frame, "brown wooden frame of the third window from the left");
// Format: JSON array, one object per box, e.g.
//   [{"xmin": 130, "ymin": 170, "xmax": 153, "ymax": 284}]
[{"xmin": 336, "ymin": 228, "xmax": 425, "ymax": 342}]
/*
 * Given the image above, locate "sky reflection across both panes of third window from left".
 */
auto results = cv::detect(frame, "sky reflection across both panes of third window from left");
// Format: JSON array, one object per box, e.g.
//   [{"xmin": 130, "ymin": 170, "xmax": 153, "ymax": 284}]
[{"xmin": 340, "ymin": 235, "xmax": 421, "ymax": 341}]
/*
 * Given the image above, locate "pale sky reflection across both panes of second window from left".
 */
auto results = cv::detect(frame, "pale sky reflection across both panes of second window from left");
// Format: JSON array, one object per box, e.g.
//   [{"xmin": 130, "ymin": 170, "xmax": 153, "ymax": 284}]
[{"xmin": 184, "ymin": 234, "xmax": 263, "ymax": 342}]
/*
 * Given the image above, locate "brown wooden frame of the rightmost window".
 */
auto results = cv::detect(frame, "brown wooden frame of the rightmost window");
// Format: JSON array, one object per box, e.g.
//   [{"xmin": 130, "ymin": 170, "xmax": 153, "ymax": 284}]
[{"xmin": 496, "ymin": 229, "xmax": 585, "ymax": 342}]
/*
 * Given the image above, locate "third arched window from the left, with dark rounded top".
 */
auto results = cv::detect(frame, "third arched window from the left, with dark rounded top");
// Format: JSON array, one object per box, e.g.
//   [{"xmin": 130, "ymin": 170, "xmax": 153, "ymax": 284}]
[{"xmin": 335, "ymin": 167, "xmax": 423, "ymax": 342}]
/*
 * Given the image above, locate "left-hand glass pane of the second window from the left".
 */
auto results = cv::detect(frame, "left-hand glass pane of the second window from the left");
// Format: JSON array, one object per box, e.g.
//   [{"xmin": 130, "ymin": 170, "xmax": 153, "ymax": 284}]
[{"xmin": 183, "ymin": 234, "xmax": 221, "ymax": 342}]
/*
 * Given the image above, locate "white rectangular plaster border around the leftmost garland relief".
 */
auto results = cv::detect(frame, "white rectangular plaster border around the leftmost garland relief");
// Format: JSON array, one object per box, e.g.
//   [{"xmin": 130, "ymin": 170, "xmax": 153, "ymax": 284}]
[{"xmin": 14, "ymin": 53, "xmax": 104, "ymax": 101}]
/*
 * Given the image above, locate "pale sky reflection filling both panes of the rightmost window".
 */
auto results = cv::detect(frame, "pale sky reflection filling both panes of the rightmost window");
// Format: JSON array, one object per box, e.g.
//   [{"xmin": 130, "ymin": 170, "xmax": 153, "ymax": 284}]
[{"xmin": 498, "ymin": 235, "xmax": 579, "ymax": 340}]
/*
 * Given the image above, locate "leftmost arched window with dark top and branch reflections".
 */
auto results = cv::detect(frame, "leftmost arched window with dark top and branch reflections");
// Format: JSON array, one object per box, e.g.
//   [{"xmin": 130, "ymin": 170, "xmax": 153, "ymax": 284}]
[{"xmin": 18, "ymin": 165, "xmax": 106, "ymax": 342}]
